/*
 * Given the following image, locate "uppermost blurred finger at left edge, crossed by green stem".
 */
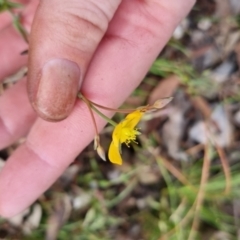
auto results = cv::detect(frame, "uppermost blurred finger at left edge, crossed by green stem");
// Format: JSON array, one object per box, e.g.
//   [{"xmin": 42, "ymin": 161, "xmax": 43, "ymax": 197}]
[{"xmin": 0, "ymin": 0, "xmax": 38, "ymax": 80}]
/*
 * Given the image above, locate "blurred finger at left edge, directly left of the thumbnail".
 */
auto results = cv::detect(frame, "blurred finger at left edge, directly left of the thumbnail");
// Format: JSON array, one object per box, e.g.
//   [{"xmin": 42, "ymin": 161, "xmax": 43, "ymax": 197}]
[{"xmin": 0, "ymin": 79, "xmax": 37, "ymax": 149}]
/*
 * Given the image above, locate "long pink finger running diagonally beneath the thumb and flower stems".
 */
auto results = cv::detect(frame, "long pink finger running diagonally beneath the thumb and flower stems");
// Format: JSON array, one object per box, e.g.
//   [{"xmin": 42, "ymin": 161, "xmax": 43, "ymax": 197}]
[{"xmin": 0, "ymin": 0, "xmax": 194, "ymax": 216}]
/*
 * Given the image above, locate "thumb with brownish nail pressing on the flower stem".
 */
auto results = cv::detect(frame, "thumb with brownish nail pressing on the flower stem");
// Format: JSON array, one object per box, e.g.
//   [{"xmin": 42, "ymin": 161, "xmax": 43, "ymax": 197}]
[{"xmin": 28, "ymin": 0, "xmax": 121, "ymax": 121}]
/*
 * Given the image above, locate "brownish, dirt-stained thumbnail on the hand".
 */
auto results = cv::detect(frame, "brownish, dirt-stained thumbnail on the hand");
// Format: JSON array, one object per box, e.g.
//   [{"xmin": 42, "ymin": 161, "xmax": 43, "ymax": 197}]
[{"xmin": 33, "ymin": 58, "xmax": 80, "ymax": 121}]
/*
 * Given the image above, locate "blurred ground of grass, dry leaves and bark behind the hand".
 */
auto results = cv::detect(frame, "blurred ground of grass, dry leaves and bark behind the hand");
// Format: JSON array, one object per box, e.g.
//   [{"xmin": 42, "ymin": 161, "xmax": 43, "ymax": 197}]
[{"xmin": 0, "ymin": 0, "xmax": 240, "ymax": 240}]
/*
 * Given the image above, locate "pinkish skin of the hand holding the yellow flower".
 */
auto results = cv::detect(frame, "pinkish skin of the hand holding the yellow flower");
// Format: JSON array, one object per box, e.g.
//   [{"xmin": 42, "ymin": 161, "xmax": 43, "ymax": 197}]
[{"xmin": 0, "ymin": 0, "xmax": 195, "ymax": 217}]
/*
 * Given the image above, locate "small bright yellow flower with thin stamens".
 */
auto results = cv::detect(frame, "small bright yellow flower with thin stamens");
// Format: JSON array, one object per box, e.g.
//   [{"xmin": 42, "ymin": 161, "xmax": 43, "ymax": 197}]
[{"xmin": 108, "ymin": 110, "xmax": 144, "ymax": 165}]
